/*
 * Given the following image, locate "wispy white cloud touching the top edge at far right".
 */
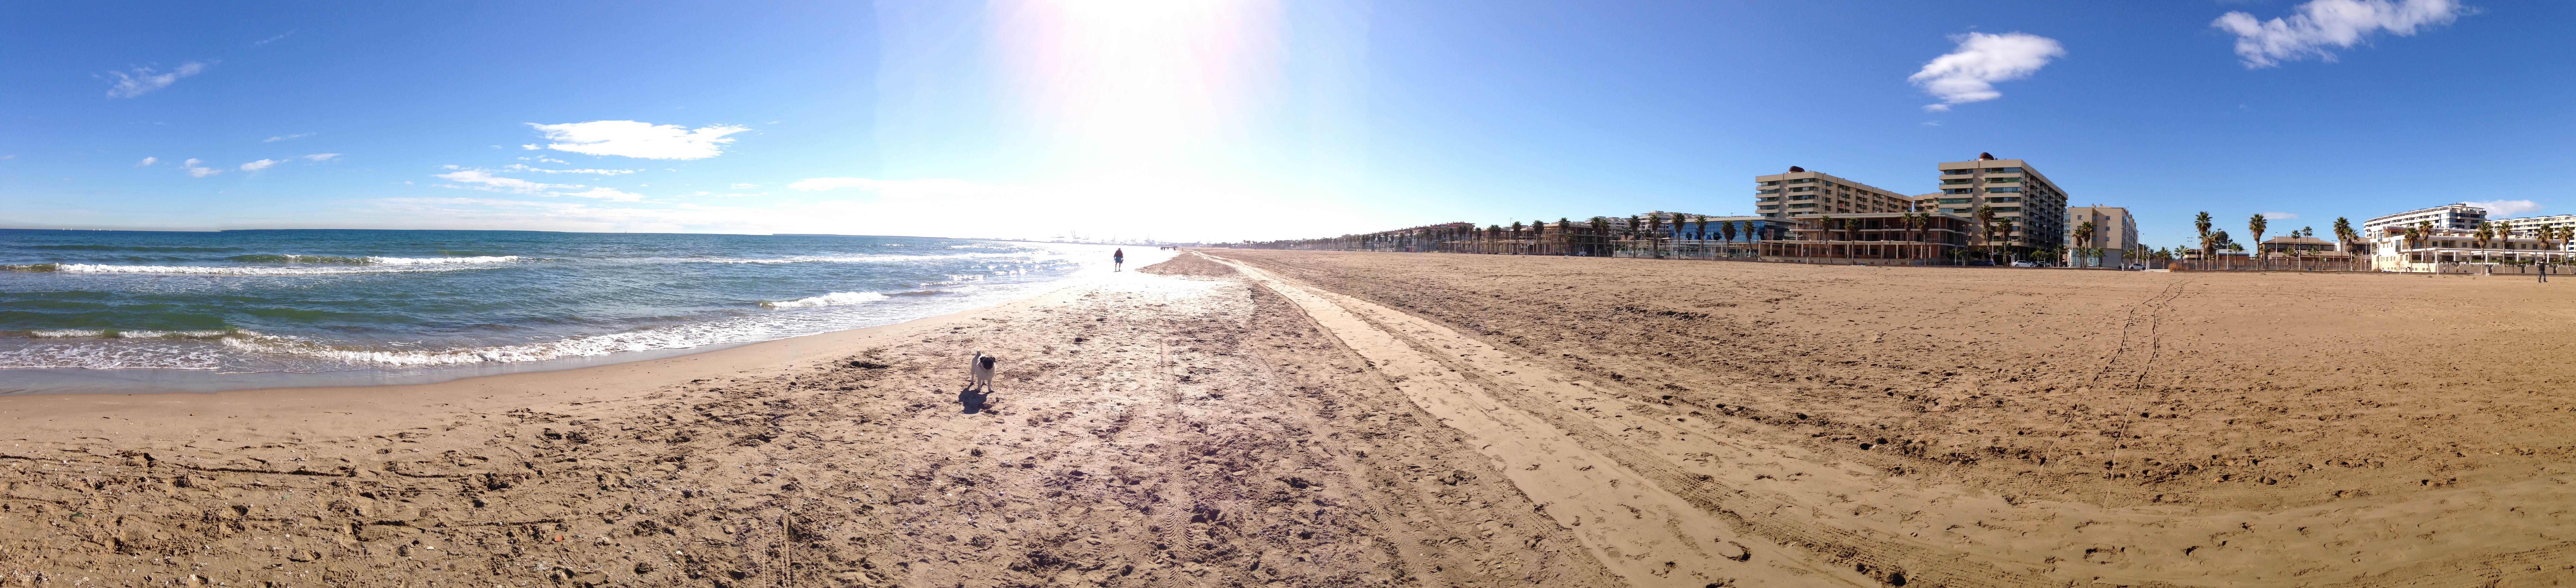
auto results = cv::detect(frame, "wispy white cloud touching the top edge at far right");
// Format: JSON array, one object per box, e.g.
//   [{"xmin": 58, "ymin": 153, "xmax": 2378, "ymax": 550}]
[{"xmin": 2210, "ymin": 0, "xmax": 2473, "ymax": 70}]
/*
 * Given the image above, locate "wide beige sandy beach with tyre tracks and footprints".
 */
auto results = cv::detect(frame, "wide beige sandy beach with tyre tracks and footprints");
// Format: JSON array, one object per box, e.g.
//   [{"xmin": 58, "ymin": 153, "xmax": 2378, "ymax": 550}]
[{"xmin": 0, "ymin": 250, "xmax": 2576, "ymax": 585}]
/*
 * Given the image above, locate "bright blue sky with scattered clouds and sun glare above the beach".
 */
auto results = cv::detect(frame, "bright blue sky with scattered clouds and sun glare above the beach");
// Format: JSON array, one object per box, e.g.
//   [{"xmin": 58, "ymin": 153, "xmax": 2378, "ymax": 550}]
[{"xmin": 0, "ymin": 0, "xmax": 2576, "ymax": 245}]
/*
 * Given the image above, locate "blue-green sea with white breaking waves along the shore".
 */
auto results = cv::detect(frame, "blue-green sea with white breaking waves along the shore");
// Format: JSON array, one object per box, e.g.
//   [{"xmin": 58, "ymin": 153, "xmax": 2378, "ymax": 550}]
[{"xmin": 0, "ymin": 230, "xmax": 1169, "ymax": 395}]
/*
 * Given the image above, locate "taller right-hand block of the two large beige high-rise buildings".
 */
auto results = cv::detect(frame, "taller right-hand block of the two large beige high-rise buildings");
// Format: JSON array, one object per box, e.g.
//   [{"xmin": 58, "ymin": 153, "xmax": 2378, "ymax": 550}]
[{"xmin": 1937, "ymin": 152, "xmax": 2066, "ymax": 253}]
